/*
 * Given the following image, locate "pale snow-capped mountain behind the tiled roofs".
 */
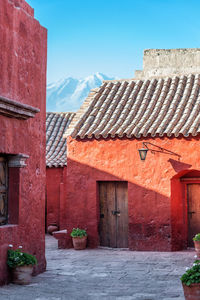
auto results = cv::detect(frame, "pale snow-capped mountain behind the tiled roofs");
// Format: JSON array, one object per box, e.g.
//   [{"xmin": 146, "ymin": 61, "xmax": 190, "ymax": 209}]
[{"xmin": 47, "ymin": 73, "xmax": 114, "ymax": 112}]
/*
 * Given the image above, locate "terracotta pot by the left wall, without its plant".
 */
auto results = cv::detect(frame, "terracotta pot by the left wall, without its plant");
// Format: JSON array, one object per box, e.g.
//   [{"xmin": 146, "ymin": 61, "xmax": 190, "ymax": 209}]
[{"xmin": 12, "ymin": 265, "xmax": 33, "ymax": 284}]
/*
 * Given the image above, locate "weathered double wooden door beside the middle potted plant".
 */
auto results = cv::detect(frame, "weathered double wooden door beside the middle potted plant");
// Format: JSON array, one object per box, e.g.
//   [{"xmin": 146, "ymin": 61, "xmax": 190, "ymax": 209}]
[{"xmin": 99, "ymin": 181, "xmax": 128, "ymax": 248}]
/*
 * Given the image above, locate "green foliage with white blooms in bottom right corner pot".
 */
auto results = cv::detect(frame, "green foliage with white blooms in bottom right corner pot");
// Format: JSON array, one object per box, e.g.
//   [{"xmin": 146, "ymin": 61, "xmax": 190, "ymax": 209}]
[{"xmin": 181, "ymin": 260, "xmax": 200, "ymax": 286}]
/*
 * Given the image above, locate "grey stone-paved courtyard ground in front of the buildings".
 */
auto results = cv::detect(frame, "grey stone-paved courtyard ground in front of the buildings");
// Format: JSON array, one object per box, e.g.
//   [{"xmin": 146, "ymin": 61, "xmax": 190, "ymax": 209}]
[{"xmin": 0, "ymin": 236, "xmax": 195, "ymax": 300}]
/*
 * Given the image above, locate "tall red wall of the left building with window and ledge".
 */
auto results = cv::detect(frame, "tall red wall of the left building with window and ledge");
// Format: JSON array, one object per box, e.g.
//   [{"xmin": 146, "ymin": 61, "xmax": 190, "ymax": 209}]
[{"xmin": 0, "ymin": 0, "xmax": 47, "ymax": 284}]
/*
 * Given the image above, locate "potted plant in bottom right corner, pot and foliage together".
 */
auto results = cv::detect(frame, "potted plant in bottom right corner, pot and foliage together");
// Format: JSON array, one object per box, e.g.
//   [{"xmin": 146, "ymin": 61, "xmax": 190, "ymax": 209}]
[{"xmin": 181, "ymin": 260, "xmax": 200, "ymax": 300}]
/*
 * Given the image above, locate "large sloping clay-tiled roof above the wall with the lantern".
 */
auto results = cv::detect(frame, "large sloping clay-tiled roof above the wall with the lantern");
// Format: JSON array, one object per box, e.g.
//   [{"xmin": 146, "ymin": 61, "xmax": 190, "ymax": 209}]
[{"xmin": 65, "ymin": 74, "xmax": 200, "ymax": 139}]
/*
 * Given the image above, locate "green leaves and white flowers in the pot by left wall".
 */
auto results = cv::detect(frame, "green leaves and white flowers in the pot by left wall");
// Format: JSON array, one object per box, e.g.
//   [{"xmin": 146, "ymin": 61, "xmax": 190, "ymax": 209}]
[{"xmin": 7, "ymin": 245, "xmax": 37, "ymax": 268}]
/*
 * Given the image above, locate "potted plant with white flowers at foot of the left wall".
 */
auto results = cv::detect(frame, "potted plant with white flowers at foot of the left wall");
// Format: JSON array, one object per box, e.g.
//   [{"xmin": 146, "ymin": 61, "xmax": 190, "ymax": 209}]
[{"xmin": 7, "ymin": 245, "xmax": 37, "ymax": 284}]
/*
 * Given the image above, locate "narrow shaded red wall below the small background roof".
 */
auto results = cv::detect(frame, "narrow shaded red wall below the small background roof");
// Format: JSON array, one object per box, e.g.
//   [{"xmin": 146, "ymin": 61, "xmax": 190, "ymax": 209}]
[{"xmin": 46, "ymin": 167, "xmax": 67, "ymax": 227}]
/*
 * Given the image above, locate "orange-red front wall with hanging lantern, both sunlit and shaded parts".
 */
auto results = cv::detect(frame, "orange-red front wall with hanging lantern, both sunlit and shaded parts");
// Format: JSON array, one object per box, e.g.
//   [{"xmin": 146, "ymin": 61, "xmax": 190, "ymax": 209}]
[{"xmin": 64, "ymin": 137, "xmax": 200, "ymax": 251}]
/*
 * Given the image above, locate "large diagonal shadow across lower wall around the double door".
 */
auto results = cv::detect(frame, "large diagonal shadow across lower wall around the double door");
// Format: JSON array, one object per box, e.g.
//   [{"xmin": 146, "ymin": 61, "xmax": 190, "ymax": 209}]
[{"xmin": 61, "ymin": 158, "xmax": 189, "ymax": 251}]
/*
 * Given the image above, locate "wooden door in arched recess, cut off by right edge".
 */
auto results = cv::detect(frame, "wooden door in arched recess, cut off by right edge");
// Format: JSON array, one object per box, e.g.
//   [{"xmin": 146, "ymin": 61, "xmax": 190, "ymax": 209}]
[{"xmin": 187, "ymin": 183, "xmax": 200, "ymax": 247}]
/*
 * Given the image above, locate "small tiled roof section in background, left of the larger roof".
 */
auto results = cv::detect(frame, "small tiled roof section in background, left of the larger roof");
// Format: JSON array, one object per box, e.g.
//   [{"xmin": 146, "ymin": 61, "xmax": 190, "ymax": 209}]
[{"xmin": 46, "ymin": 113, "xmax": 75, "ymax": 167}]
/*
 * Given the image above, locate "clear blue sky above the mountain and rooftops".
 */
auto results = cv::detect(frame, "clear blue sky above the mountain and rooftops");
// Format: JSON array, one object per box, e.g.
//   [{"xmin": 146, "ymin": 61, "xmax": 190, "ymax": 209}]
[{"xmin": 27, "ymin": 0, "xmax": 200, "ymax": 82}]
